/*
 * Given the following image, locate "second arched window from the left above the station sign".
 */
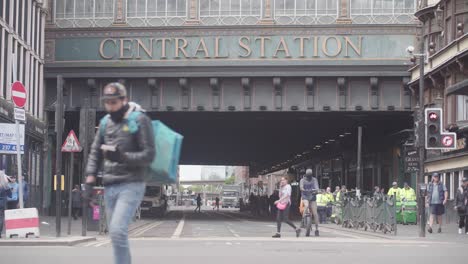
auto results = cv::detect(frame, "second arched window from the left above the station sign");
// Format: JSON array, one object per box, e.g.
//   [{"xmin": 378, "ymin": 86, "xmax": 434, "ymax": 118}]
[{"xmin": 127, "ymin": 0, "xmax": 187, "ymax": 27}]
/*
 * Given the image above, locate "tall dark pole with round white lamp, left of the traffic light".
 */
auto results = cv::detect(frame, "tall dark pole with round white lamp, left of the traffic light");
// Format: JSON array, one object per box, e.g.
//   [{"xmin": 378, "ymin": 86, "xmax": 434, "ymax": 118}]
[{"xmin": 406, "ymin": 44, "xmax": 426, "ymax": 237}]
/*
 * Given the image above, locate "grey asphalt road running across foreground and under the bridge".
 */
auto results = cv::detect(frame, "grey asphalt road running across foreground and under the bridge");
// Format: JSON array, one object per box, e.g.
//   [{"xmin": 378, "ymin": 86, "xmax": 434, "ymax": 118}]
[{"xmin": 0, "ymin": 210, "xmax": 468, "ymax": 264}]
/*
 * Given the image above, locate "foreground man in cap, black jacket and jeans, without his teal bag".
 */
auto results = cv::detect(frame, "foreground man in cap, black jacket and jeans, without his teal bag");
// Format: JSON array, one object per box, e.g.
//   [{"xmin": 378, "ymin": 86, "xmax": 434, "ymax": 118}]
[{"xmin": 83, "ymin": 83, "xmax": 156, "ymax": 264}]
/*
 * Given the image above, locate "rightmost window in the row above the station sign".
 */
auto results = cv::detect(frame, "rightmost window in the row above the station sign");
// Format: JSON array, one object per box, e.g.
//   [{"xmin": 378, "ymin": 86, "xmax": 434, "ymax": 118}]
[{"xmin": 350, "ymin": 0, "xmax": 416, "ymax": 24}]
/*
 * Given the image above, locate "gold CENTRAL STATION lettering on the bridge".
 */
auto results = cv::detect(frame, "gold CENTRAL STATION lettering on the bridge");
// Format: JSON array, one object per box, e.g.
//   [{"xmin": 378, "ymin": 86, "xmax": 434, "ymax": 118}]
[{"xmin": 99, "ymin": 36, "xmax": 362, "ymax": 60}]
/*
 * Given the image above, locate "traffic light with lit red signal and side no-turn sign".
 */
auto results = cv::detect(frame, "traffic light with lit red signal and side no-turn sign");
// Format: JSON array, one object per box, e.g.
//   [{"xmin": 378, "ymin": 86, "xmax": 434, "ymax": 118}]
[{"xmin": 424, "ymin": 108, "xmax": 457, "ymax": 149}]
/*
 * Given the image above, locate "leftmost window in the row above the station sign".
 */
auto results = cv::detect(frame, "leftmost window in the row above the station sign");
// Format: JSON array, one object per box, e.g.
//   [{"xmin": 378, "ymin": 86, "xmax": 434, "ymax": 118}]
[{"xmin": 54, "ymin": 0, "xmax": 115, "ymax": 27}]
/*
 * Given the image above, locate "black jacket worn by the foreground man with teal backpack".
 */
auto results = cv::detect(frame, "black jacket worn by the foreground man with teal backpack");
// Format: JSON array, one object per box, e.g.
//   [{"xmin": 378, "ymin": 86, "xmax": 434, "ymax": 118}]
[{"xmin": 86, "ymin": 109, "xmax": 156, "ymax": 186}]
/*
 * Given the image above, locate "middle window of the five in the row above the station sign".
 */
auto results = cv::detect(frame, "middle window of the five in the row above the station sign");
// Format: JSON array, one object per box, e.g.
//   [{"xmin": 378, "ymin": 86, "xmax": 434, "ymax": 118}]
[{"xmin": 200, "ymin": 0, "xmax": 262, "ymax": 25}]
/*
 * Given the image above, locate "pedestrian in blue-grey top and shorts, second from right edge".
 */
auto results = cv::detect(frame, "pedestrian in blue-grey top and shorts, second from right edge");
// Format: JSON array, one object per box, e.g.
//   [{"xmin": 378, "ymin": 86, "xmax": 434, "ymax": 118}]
[{"xmin": 426, "ymin": 172, "xmax": 448, "ymax": 233}]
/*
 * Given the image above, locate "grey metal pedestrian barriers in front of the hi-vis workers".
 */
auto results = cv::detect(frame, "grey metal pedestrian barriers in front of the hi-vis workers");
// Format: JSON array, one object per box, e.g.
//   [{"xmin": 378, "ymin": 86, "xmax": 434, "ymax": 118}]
[{"xmin": 341, "ymin": 196, "xmax": 397, "ymax": 234}]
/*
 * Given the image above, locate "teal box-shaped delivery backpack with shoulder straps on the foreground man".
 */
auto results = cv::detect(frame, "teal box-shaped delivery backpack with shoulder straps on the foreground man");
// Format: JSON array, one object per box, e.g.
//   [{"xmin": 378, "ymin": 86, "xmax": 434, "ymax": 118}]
[{"xmin": 99, "ymin": 111, "xmax": 184, "ymax": 184}]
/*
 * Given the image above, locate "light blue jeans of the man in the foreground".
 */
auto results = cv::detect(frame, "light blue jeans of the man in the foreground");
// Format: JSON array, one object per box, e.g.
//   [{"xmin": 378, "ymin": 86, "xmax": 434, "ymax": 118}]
[{"xmin": 104, "ymin": 182, "xmax": 145, "ymax": 264}]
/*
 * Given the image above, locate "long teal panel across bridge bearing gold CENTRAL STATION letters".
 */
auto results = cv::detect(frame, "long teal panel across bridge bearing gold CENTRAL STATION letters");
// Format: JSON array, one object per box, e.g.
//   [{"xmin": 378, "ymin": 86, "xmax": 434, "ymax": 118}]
[{"xmin": 55, "ymin": 35, "xmax": 414, "ymax": 63}]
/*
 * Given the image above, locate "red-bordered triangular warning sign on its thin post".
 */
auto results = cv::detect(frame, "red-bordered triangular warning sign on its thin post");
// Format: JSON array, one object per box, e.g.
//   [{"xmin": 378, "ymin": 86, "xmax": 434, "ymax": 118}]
[{"xmin": 62, "ymin": 130, "xmax": 82, "ymax": 235}]
